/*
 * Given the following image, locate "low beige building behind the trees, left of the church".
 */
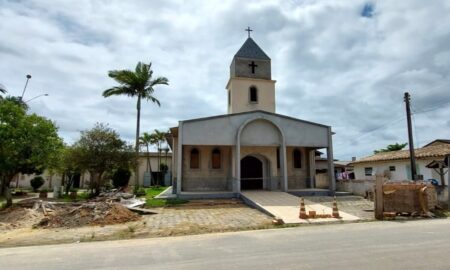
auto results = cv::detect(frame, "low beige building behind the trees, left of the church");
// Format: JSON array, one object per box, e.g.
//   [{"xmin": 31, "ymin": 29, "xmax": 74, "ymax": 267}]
[{"xmin": 10, "ymin": 152, "xmax": 172, "ymax": 189}]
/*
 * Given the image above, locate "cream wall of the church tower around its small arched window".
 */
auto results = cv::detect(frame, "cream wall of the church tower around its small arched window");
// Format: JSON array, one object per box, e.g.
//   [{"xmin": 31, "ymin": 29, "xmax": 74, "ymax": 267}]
[{"xmin": 227, "ymin": 78, "xmax": 275, "ymax": 113}]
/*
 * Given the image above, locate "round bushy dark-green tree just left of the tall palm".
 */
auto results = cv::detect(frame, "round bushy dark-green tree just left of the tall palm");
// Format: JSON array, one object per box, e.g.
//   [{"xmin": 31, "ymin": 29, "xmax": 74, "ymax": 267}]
[{"xmin": 73, "ymin": 123, "xmax": 136, "ymax": 195}]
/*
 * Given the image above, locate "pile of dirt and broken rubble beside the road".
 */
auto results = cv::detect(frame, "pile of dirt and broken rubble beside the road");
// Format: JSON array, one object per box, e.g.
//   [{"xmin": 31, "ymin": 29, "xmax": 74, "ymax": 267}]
[{"xmin": 0, "ymin": 192, "xmax": 152, "ymax": 229}]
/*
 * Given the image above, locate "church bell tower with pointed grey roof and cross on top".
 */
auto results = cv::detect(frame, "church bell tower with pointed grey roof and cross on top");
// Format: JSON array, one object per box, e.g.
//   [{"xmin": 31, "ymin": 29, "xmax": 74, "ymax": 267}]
[{"xmin": 226, "ymin": 28, "xmax": 276, "ymax": 114}]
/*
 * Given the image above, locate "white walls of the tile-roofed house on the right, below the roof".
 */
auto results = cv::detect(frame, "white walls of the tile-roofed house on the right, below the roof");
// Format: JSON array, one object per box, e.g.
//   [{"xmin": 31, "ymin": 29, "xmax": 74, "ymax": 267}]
[{"xmin": 354, "ymin": 159, "xmax": 447, "ymax": 184}]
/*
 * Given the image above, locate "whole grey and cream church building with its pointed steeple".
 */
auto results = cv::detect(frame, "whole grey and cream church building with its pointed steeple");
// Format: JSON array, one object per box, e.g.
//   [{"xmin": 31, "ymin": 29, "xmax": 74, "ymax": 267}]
[{"xmin": 168, "ymin": 37, "xmax": 335, "ymax": 196}]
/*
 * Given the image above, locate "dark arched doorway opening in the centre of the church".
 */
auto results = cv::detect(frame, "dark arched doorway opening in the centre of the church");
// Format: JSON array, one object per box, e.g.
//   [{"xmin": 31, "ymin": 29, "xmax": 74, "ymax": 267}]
[{"xmin": 241, "ymin": 156, "xmax": 263, "ymax": 190}]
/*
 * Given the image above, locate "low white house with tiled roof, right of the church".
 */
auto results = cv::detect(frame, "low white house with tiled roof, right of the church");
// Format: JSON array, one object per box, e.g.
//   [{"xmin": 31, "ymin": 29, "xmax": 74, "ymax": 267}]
[{"xmin": 352, "ymin": 140, "xmax": 450, "ymax": 185}]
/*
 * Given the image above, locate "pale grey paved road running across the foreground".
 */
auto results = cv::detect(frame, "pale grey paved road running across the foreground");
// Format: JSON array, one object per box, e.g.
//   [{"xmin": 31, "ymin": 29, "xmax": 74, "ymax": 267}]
[{"xmin": 0, "ymin": 220, "xmax": 450, "ymax": 270}]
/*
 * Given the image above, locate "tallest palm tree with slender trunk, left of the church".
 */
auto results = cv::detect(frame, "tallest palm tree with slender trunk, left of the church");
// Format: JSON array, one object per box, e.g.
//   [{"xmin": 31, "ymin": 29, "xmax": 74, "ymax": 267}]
[{"xmin": 103, "ymin": 62, "xmax": 169, "ymax": 187}]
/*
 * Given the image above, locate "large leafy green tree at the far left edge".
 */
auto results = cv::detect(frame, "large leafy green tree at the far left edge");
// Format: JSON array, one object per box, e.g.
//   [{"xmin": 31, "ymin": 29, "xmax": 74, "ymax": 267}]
[{"xmin": 0, "ymin": 99, "xmax": 62, "ymax": 206}]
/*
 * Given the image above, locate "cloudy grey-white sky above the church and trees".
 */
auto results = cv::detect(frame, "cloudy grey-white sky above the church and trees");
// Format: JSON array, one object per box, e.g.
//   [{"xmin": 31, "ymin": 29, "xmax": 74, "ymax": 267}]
[{"xmin": 0, "ymin": 0, "xmax": 450, "ymax": 160}]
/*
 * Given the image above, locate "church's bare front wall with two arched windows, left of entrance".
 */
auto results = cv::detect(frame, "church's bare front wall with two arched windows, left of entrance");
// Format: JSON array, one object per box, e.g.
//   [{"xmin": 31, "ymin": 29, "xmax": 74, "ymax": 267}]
[{"xmin": 181, "ymin": 145, "xmax": 232, "ymax": 191}]
